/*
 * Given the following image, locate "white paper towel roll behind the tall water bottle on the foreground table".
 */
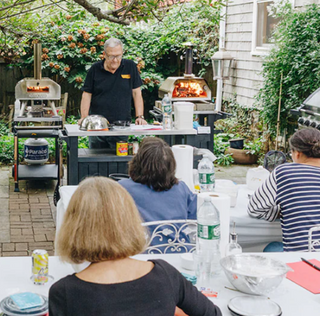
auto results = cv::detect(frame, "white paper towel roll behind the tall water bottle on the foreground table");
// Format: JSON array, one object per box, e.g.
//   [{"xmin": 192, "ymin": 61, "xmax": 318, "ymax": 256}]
[{"xmin": 197, "ymin": 192, "xmax": 231, "ymax": 258}]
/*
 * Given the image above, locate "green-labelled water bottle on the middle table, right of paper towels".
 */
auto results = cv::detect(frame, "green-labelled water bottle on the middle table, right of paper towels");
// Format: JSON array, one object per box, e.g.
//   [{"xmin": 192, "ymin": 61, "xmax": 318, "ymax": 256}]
[{"xmin": 198, "ymin": 155, "xmax": 215, "ymax": 192}]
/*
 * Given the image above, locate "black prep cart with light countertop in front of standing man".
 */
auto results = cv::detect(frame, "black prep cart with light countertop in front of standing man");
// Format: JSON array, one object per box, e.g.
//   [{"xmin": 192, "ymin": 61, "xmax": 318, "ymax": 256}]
[{"xmin": 59, "ymin": 124, "xmax": 201, "ymax": 185}]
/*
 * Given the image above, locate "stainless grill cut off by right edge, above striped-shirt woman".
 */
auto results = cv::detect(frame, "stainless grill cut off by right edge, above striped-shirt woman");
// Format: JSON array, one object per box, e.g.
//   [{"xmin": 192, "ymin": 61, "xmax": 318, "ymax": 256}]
[{"xmin": 291, "ymin": 88, "xmax": 320, "ymax": 130}]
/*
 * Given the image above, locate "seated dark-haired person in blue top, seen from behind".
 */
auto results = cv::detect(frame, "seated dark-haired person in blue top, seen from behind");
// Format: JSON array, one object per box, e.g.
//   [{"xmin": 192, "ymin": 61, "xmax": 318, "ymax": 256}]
[{"xmin": 119, "ymin": 137, "xmax": 197, "ymax": 249}]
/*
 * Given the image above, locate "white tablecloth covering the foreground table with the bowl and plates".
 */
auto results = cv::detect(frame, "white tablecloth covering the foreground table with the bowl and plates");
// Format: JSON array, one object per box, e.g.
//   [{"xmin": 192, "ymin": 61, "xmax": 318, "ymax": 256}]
[{"xmin": 0, "ymin": 253, "xmax": 320, "ymax": 316}]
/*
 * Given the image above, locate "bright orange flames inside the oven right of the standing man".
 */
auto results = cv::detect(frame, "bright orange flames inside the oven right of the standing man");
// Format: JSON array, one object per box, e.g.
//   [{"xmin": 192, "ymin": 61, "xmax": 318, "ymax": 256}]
[{"xmin": 172, "ymin": 80, "xmax": 207, "ymax": 98}]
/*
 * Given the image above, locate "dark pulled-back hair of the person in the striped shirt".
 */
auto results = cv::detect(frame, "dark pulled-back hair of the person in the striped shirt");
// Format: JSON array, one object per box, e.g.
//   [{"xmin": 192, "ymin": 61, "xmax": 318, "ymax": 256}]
[{"xmin": 289, "ymin": 128, "xmax": 320, "ymax": 158}]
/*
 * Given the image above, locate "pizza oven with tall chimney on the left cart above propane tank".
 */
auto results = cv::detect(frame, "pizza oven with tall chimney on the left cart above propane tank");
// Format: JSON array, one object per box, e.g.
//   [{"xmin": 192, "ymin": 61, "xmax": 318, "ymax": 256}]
[{"xmin": 14, "ymin": 44, "xmax": 62, "ymax": 128}]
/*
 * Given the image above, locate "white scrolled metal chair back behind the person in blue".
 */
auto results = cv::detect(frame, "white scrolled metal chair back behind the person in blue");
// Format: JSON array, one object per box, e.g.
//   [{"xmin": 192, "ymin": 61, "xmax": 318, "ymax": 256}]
[{"xmin": 142, "ymin": 219, "xmax": 197, "ymax": 254}]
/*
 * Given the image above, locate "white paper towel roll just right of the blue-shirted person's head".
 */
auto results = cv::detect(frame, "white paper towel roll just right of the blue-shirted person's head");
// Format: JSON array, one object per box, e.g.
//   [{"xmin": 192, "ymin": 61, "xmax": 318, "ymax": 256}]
[{"xmin": 171, "ymin": 145, "xmax": 195, "ymax": 192}]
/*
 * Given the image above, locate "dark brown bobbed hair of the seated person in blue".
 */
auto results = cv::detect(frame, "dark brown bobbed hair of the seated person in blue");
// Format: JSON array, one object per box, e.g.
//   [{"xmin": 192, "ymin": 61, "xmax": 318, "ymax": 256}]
[{"xmin": 129, "ymin": 137, "xmax": 179, "ymax": 192}]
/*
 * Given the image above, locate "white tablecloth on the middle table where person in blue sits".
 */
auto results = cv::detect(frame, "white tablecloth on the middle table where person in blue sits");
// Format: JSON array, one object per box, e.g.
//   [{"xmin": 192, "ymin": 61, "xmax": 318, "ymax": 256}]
[{"xmin": 56, "ymin": 185, "xmax": 282, "ymax": 252}]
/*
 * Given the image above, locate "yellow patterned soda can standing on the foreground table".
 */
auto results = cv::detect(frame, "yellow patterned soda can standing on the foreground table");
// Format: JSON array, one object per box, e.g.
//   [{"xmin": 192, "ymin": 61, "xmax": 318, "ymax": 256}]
[{"xmin": 32, "ymin": 249, "xmax": 49, "ymax": 285}]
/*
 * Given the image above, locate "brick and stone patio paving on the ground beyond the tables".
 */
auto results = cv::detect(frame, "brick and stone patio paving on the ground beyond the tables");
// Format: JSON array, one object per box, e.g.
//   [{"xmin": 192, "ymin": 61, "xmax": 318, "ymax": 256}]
[{"xmin": 0, "ymin": 165, "xmax": 252, "ymax": 257}]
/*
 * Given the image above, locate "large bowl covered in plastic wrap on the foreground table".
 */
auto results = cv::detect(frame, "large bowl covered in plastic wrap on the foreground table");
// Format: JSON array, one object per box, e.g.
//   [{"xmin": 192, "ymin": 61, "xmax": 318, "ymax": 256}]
[{"xmin": 220, "ymin": 254, "xmax": 292, "ymax": 295}]
